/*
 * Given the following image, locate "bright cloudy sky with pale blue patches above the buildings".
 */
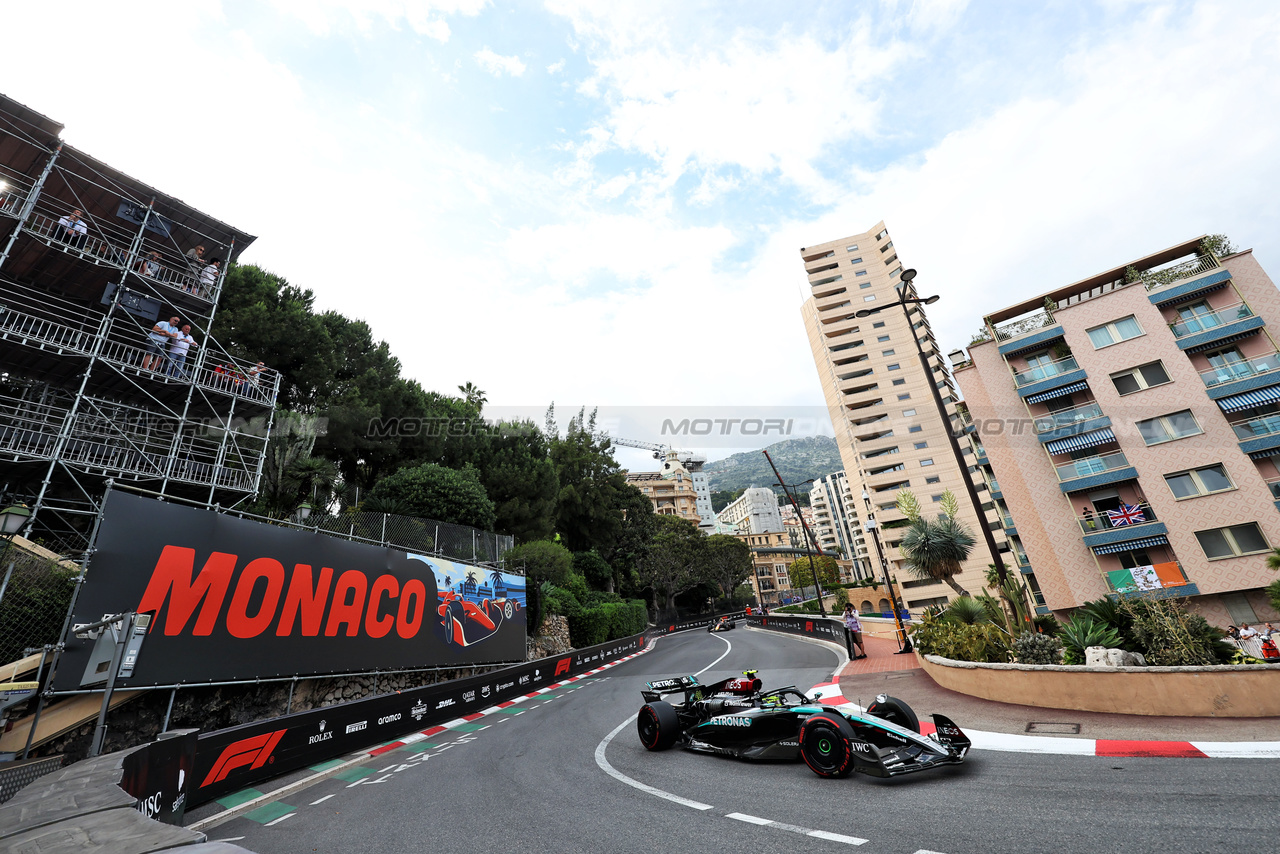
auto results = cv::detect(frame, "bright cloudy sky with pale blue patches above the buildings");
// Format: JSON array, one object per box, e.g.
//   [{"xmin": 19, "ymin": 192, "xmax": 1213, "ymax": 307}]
[{"xmin": 0, "ymin": 0, "xmax": 1280, "ymax": 473}]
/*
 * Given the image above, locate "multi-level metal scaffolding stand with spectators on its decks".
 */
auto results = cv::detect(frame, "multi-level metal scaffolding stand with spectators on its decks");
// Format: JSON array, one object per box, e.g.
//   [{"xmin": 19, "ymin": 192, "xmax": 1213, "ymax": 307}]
[{"xmin": 0, "ymin": 96, "xmax": 279, "ymax": 552}]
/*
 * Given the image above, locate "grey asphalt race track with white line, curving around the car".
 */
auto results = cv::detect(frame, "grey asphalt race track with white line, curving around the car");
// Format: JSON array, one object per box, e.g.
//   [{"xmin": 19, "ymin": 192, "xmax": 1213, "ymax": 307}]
[{"xmin": 199, "ymin": 630, "xmax": 1280, "ymax": 854}]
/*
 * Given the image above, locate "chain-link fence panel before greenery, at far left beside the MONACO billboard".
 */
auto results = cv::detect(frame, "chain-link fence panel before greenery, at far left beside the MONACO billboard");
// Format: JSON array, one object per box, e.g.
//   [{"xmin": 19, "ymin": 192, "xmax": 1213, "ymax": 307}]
[{"xmin": 0, "ymin": 542, "xmax": 81, "ymax": 665}]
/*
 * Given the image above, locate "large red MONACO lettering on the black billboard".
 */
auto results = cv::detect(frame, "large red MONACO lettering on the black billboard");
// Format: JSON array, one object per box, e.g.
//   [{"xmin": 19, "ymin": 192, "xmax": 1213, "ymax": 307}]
[{"xmin": 138, "ymin": 545, "xmax": 428, "ymax": 639}]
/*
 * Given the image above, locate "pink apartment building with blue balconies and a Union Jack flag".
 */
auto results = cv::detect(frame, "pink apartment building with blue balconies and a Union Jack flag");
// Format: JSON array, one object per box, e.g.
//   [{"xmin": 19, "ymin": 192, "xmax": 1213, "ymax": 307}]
[{"xmin": 952, "ymin": 238, "xmax": 1280, "ymax": 625}]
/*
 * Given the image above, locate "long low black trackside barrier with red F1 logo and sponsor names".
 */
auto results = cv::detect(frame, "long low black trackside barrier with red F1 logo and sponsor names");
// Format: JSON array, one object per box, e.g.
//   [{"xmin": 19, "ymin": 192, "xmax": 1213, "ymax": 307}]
[{"xmin": 189, "ymin": 635, "xmax": 645, "ymax": 804}]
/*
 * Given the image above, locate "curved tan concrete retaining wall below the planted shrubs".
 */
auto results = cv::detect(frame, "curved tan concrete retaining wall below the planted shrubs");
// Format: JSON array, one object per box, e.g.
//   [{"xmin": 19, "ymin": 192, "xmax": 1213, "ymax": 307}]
[{"xmin": 915, "ymin": 653, "xmax": 1280, "ymax": 717}]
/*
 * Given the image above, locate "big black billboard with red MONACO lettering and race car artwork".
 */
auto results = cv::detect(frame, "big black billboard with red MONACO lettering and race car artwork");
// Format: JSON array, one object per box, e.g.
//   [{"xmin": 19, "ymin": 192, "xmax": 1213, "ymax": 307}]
[{"xmin": 54, "ymin": 492, "xmax": 526, "ymax": 690}]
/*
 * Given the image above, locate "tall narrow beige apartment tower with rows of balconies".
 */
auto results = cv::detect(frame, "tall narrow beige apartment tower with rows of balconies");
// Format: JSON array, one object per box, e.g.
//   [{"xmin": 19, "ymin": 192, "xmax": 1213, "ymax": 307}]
[{"xmin": 800, "ymin": 223, "xmax": 1009, "ymax": 608}]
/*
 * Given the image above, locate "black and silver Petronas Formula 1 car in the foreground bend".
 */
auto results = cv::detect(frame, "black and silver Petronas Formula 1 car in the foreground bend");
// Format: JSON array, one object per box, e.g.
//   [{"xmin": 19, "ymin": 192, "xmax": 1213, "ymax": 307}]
[{"xmin": 636, "ymin": 671, "xmax": 970, "ymax": 777}]
